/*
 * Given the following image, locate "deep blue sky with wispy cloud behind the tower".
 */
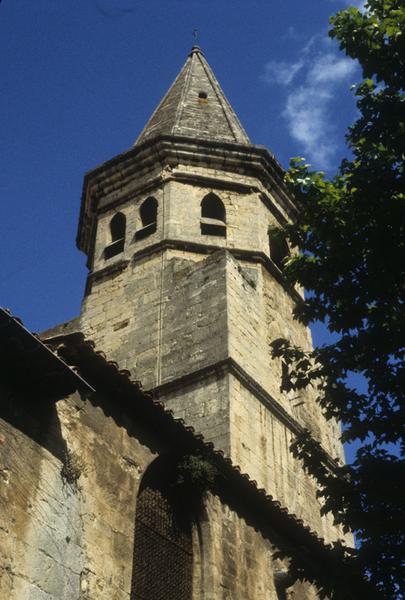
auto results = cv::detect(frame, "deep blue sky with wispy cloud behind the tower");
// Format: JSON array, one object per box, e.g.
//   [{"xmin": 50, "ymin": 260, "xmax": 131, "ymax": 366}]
[{"xmin": 0, "ymin": 0, "xmax": 360, "ymax": 331}]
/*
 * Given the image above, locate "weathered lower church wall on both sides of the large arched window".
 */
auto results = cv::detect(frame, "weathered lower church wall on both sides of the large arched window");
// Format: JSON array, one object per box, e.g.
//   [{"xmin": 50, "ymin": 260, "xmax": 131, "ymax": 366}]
[{"xmin": 0, "ymin": 382, "xmax": 326, "ymax": 600}]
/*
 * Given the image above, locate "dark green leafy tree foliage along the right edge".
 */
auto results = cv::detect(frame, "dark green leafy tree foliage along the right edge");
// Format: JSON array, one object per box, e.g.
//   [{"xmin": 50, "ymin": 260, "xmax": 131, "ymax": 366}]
[{"xmin": 273, "ymin": 0, "xmax": 405, "ymax": 599}]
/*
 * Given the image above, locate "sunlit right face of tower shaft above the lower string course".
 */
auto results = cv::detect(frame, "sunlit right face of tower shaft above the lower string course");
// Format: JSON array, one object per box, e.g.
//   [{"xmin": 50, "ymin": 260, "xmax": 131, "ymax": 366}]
[{"xmin": 227, "ymin": 256, "xmax": 343, "ymax": 459}]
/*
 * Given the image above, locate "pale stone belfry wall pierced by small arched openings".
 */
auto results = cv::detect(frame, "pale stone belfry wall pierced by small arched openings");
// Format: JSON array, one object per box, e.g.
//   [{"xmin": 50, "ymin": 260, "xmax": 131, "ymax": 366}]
[{"xmin": 92, "ymin": 171, "xmax": 288, "ymax": 271}]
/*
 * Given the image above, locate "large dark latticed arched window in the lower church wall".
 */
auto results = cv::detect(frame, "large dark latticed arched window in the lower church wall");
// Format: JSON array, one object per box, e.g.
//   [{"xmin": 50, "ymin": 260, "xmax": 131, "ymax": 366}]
[{"xmin": 131, "ymin": 459, "xmax": 193, "ymax": 600}]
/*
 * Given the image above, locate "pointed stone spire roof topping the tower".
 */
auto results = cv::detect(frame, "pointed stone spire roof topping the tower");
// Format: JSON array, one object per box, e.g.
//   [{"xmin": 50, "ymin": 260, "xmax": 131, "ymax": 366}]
[{"xmin": 135, "ymin": 46, "xmax": 250, "ymax": 146}]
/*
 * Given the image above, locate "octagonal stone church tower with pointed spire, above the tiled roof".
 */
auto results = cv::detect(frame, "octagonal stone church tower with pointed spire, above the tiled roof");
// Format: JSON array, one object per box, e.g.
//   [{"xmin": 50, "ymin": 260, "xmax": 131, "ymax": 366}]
[{"xmin": 72, "ymin": 47, "xmax": 342, "ymax": 541}]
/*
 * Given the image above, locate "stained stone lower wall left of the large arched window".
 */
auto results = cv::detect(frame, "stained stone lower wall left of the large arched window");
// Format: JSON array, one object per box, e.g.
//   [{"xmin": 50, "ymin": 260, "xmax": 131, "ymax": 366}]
[{"xmin": 0, "ymin": 384, "xmax": 156, "ymax": 600}]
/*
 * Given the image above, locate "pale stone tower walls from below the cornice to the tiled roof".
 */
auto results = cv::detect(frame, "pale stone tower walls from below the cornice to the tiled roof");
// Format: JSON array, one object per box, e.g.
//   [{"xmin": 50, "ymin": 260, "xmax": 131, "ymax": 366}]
[{"xmin": 81, "ymin": 169, "xmax": 342, "ymax": 541}]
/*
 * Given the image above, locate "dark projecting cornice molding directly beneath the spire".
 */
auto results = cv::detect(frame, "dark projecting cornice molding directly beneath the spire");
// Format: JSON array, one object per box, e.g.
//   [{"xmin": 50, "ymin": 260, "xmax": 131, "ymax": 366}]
[{"xmin": 77, "ymin": 136, "xmax": 296, "ymax": 254}]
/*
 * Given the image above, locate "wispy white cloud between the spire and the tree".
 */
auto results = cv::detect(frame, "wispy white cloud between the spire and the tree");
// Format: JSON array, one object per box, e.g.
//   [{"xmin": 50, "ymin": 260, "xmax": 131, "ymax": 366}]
[{"xmin": 262, "ymin": 35, "xmax": 357, "ymax": 169}]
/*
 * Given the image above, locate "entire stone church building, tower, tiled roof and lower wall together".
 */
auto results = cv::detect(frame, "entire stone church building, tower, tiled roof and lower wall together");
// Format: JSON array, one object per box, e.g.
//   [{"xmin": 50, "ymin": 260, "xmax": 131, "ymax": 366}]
[{"xmin": 0, "ymin": 47, "xmax": 352, "ymax": 600}]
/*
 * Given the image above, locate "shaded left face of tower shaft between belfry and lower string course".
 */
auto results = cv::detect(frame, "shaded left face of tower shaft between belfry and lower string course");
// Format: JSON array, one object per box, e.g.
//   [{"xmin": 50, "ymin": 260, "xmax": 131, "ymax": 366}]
[{"xmin": 81, "ymin": 251, "xmax": 227, "ymax": 389}]
